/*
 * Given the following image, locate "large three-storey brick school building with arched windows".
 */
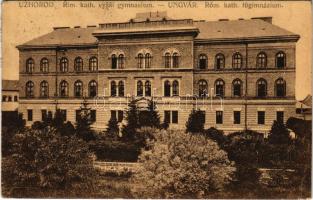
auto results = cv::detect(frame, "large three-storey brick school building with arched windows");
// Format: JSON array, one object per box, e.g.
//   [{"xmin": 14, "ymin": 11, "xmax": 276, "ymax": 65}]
[{"xmin": 17, "ymin": 12, "xmax": 299, "ymax": 133}]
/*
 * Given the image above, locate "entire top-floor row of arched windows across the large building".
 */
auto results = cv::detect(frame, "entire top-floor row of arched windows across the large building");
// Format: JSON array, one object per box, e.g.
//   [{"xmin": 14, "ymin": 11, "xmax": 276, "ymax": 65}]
[{"xmin": 26, "ymin": 51, "xmax": 286, "ymax": 73}]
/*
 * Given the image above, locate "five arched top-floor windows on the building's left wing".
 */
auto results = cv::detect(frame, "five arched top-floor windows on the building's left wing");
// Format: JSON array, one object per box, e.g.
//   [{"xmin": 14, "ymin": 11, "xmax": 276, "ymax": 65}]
[{"xmin": 26, "ymin": 57, "xmax": 98, "ymax": 73}]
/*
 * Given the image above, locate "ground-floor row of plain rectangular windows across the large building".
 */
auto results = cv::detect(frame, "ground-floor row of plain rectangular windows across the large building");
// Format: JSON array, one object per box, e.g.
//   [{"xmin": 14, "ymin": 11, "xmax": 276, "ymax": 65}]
[{"xmin": 27, "ymin": 109, "xmax": 284, "ymax": 125}]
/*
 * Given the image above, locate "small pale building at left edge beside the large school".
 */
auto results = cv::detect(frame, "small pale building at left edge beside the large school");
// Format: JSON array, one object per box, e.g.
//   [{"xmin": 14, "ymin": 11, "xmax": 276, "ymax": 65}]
[{"xmin": 1, "ymin": 80, "xmax": 19, "ymax": 111}]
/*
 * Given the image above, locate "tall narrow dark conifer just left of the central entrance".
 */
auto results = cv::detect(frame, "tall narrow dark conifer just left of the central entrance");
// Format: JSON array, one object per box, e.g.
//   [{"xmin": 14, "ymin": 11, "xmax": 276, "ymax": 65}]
[{"xmin": 122, "ymin": 99, "xmax": 140, "ymax": 139}]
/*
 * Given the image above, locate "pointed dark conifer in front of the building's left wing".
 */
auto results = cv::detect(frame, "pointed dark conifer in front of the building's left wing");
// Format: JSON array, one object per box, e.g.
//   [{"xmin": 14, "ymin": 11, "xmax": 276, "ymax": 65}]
[{"xmin": 76, "ymin": 99, "xmax": 96, "ymax": 141}]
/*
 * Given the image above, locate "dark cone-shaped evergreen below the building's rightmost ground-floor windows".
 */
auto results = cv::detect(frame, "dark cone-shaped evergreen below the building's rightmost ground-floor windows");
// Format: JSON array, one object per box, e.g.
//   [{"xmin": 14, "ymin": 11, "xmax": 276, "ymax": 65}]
[{"xmin": 268, "ymin": 120, "xmax": 291, "ymax": 145}]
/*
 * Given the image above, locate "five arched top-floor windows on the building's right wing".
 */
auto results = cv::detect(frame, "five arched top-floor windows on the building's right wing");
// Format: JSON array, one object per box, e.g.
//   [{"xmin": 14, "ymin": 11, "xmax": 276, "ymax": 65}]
[{"xmin": 198, "ymin": 51, "xmax": 286, "ymax": 70}]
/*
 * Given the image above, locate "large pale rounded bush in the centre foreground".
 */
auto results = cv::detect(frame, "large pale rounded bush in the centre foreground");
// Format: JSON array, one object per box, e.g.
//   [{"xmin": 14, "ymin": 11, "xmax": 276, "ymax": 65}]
[{"xmin": 132, "ymin": 131, "xmax": 235, "ymax": 198}]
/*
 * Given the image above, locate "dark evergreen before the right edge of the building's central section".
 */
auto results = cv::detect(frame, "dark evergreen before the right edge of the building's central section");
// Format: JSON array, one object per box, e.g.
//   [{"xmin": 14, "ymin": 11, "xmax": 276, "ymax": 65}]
[{"xmin": 186, "ymin": 109, "xmax": 204, "ymax": 133}]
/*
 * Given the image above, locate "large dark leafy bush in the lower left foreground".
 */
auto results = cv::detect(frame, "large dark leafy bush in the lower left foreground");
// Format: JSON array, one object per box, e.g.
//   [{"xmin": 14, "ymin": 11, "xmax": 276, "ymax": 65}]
[{"xmin": 2, "ymin": 127, "xmax": 96, "ymax": 194}]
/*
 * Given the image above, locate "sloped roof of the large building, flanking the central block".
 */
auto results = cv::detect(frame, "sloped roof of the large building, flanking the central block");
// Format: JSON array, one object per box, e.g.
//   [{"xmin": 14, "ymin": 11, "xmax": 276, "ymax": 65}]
[{"xmin": 18, "ymin": 19, "xmax": 299, "ymax": 48}]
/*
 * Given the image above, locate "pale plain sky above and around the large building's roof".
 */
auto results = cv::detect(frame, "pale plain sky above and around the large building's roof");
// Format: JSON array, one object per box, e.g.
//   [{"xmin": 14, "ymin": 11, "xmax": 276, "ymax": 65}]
[{"xmin": 1, "ymin": 1, "xmax": 312, "ymax": 100}]
